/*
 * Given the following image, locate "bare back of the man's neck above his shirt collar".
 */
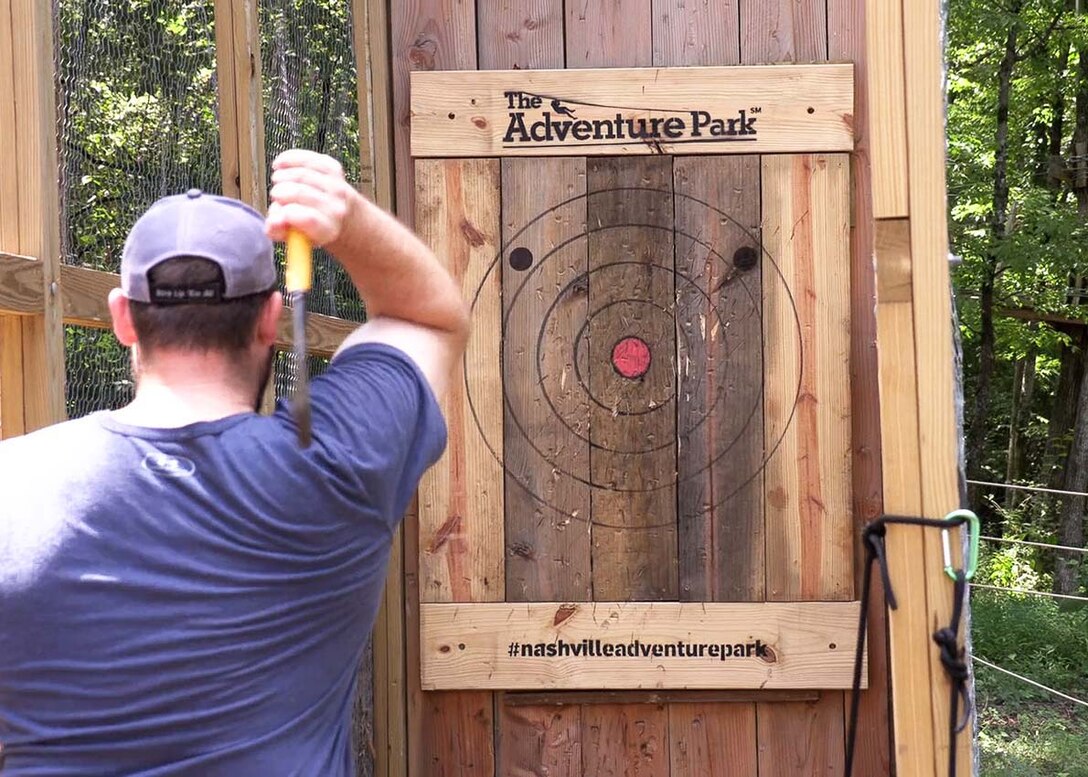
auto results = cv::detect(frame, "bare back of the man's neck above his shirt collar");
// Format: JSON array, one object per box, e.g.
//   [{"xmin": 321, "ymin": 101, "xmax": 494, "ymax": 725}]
[{"xmin": 114, "ymin": 354, "xmax": 255, "ymax": 428}]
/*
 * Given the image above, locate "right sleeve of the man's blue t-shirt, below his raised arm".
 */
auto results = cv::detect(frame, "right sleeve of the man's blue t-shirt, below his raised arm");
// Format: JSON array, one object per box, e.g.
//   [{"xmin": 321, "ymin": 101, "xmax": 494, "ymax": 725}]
[{"xmin": 275, "ymin": 343, "xmax": 447, "ymax": 526}]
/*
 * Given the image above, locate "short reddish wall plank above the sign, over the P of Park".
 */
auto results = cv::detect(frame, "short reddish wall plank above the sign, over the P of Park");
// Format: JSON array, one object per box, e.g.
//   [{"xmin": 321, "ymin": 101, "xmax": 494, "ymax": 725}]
[{"xmin": 653, "ymin": 0, "xmax": 741, "ymax": 66}]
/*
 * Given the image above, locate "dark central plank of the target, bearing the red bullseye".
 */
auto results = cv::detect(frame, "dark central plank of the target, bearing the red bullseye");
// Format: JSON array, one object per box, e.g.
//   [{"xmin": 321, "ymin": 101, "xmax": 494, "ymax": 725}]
[{"xmin": 574, "ymin": 158, "xmax": 678, "ymax": 601}]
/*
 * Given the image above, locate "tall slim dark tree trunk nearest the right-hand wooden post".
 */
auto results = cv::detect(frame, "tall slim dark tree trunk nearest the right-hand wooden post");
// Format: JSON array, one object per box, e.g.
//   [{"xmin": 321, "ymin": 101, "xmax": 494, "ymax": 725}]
[{"xmin": 967, "ymin": 12, "xmax": 1022, "ymax": 513}]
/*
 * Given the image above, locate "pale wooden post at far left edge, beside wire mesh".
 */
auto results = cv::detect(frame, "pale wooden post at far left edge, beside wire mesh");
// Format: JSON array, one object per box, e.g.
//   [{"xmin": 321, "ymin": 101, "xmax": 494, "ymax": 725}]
[{"xmin": 0, "ymin": 0, "xmax": 65, "ymax": 437}]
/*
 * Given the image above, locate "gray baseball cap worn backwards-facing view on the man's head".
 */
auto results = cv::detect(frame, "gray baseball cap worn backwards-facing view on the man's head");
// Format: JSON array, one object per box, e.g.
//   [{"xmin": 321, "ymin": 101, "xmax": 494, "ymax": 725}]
[{"xmin": 121, "ymin": 189, "xmax": 276, "ymax": 305}]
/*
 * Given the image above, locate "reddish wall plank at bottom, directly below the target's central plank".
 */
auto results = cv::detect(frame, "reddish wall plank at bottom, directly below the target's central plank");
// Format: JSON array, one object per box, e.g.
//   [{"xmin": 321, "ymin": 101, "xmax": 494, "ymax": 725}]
[{"xmin": 582, "ymin": 704, "xmax": 669, "ymax": 777}]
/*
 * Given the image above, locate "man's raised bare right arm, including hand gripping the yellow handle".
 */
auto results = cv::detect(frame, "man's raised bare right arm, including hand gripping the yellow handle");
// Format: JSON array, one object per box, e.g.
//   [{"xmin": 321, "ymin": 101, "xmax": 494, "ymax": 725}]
[{"xmin": 268, "ymin": 150, "xmax": 469, "ymax": 396}]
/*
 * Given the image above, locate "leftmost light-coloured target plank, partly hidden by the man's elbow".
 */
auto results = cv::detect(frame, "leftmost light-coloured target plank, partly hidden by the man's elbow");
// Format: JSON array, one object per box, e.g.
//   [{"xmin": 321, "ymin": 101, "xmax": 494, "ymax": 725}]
[{"xmin": 416, "ymin": 159, "xmax": 504, "ymax": 602}]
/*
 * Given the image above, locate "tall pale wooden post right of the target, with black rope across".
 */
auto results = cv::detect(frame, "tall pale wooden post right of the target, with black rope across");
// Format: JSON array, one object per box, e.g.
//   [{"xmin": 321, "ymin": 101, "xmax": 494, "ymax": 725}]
[{"xmin": 866, "ymin": 0, "xmax": 973, "ymax": 777}]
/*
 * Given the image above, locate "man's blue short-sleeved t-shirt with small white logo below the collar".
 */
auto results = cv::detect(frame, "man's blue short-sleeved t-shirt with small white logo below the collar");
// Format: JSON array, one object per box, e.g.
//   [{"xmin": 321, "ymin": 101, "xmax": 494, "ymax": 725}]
[{"xmin": 0, "ymin": 344, "xmax": 446, "ymax": 777}]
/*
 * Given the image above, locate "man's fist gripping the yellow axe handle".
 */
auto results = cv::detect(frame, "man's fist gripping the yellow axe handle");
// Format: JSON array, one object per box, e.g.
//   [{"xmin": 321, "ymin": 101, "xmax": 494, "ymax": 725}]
[{"xmin": 265, "ymin": 149, "xmax": 361, "ymax": 247}]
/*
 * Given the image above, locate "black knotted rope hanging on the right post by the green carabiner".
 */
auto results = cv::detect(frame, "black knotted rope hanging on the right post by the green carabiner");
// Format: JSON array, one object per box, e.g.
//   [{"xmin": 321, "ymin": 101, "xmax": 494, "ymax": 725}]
[{"xmin": 844, "ymin": 516, "xmax": 970, "ymax": 777}]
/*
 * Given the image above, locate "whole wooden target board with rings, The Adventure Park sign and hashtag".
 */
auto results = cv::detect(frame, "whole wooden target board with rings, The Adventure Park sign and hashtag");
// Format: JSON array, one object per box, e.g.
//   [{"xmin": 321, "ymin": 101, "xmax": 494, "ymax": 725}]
[{"xmin": 411, "ymin": 65, "xmax": 865, "ymax": 690}]
